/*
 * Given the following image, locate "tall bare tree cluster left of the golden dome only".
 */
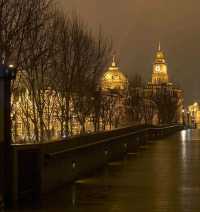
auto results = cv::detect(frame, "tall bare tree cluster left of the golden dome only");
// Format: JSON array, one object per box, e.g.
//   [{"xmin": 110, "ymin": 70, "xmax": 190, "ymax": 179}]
[{"xmin": 3, "ymin": 0, "xmax": 112, "ymax": 142}]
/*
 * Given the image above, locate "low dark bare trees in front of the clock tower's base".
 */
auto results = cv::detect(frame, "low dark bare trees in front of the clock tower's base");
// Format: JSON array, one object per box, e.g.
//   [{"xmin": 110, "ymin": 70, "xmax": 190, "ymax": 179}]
[{"xmin": 127, "ymin": 74, "xmax": 183, "ymax": 124}]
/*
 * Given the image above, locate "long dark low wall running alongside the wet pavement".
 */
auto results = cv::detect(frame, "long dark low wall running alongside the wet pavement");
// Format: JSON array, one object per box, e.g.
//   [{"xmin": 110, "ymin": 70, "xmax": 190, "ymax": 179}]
[{"xmin": 12, "ymin": 125, "xmax": 183, "ymax": 205}]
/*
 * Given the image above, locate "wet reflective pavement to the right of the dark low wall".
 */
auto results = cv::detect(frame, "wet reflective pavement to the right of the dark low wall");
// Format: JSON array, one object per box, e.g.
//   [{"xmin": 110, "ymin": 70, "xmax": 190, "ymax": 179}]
[{"xmin": 10, "ymin": 130, "xmax": 200, "ymax": 212}]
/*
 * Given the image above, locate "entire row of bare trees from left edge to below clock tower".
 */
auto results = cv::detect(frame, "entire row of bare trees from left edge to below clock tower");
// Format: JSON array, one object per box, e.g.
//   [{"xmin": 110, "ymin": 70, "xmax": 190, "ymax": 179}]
[{"xmin": 0, "ymin": 0, "xmax": 182, "ymax": 142}]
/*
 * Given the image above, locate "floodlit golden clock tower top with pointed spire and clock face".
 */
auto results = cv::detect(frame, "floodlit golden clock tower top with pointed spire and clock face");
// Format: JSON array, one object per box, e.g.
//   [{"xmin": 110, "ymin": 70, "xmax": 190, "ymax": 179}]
[{"xmin": 152, "ymin": 43, "xmax": 169, "ymax": 84}]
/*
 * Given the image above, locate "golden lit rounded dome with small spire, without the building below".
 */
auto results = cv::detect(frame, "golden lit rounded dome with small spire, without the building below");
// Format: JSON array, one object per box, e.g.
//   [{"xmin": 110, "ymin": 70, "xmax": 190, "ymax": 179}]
[{"xmin": 101, "ymin": 57, "xmax": 128, "ymax": 91}]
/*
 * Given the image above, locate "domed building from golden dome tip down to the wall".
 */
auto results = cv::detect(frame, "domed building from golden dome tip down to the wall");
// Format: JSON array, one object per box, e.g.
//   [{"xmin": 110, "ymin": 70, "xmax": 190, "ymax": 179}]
[{"xmin": 100, "ymin": 56, "xmax": 128, "ymax": 128}]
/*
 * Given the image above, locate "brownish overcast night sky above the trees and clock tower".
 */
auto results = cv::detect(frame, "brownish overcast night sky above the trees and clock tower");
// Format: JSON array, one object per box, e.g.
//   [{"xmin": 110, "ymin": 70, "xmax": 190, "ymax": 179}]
[{"xmin": 58, "ymin": 0, "xmax": 200, "ymax": 104}]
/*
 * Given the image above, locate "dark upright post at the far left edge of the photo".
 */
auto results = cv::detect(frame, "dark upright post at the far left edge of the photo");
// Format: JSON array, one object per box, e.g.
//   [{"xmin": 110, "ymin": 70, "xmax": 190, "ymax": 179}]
[{"xmin": 0, "ymin": 64, "xmax": 16, "ymax": 209}]
